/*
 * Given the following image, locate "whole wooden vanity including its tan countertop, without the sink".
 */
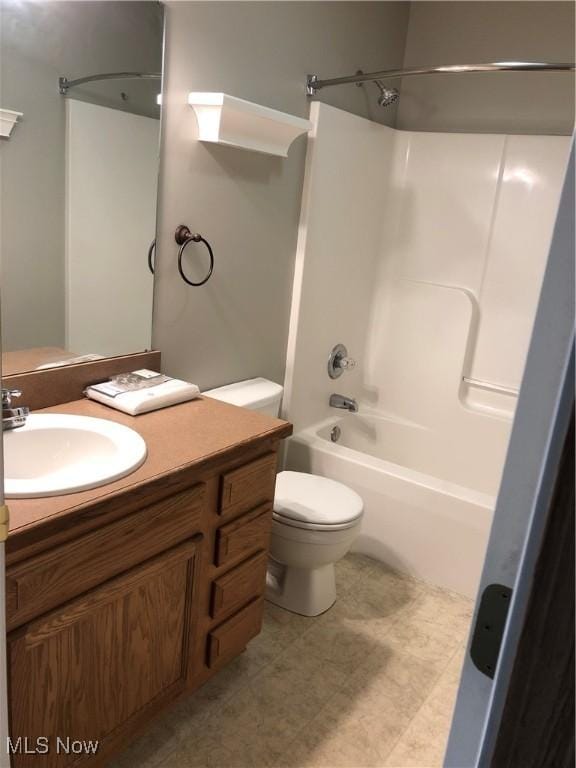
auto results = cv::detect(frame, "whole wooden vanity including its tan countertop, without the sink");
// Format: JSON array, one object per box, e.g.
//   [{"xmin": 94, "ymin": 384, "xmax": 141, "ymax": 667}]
[{"xmin": 6, "ymin": 390, "xmax": 291, "ymax": 768}]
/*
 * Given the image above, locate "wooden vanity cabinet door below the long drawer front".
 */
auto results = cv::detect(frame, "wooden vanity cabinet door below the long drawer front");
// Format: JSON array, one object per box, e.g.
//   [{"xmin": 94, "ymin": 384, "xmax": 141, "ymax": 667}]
[{"xmin": 8, "ymin": 537, "xmax": 201, "ymax": 768}]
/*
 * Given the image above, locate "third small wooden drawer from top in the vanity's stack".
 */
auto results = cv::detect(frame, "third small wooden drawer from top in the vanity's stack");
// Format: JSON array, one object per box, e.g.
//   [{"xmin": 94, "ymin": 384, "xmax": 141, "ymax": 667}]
[{"xmin": 211, "ymin": 552, "xmax": 268, "ymax": 619}]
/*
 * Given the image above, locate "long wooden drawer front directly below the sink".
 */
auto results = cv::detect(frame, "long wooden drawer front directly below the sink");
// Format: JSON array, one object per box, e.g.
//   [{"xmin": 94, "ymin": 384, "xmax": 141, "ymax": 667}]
[{"xmin": 6, "ymin": 483, "xmax": 205, "ymax": 629}]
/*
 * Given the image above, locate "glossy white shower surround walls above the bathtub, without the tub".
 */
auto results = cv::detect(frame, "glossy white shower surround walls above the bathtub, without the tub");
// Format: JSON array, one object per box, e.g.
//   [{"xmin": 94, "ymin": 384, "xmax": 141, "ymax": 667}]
[{"xmin": 286, "ymin": 105, "xmax": 569, "ymax": 493}]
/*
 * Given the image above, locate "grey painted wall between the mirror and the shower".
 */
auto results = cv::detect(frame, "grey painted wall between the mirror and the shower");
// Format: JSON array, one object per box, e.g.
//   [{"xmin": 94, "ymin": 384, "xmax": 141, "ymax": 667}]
[{"xmin": 153, "ymin": 2, "xmax": 408, "ymax": 388}]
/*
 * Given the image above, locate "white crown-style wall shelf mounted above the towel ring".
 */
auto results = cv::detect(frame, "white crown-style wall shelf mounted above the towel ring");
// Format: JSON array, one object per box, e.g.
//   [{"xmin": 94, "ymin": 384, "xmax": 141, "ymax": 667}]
[{"xmin": 188, "ymin": 92, "xmax": 312, "ymax": 157}]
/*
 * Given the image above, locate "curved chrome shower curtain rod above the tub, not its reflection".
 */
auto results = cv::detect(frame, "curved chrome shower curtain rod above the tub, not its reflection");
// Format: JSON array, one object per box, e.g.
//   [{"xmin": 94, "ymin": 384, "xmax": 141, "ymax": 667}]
[{"xmin": 306, "ymin": 61, "xmax": 575, "ymax": 96}]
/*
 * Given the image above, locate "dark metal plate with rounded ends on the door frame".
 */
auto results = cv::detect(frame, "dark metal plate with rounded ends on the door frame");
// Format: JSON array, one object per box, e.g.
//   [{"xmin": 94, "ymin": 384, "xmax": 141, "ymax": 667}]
[{"xmin": 470, "ymin": 584, "xmax": 512, "ymax": 678}]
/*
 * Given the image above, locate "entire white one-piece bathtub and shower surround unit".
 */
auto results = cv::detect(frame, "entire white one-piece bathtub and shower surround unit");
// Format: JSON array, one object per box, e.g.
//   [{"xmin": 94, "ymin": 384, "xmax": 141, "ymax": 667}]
[{"xmin": 283, "ymin": 102, "xmax": 570, "ymax": 596}]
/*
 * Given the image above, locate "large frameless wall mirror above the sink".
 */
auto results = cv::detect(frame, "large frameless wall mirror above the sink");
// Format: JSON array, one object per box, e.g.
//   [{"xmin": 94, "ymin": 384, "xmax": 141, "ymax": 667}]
[{"xmin": 0, "ymin": 0, "xmax": 163, "ymax": 375}]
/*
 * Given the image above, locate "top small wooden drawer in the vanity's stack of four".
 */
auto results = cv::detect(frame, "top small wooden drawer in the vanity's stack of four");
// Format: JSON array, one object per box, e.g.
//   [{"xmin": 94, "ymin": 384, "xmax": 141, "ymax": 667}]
[{"xmin": 219, "ymin": 453, "xmax": 276, "ymax": 517}]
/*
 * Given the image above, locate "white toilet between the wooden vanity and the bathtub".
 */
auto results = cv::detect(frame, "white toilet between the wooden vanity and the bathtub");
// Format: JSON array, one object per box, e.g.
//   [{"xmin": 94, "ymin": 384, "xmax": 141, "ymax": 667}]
[{"xmin": 203, "ymin": 378, "xmax": 363, "ymax": 616}]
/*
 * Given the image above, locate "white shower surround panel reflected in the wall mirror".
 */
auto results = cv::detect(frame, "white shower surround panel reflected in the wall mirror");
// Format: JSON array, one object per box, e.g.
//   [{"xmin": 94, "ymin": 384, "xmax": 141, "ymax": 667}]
[{"xmin": 66, "ymin": 99, "xmax": 160, "ymax": 355}]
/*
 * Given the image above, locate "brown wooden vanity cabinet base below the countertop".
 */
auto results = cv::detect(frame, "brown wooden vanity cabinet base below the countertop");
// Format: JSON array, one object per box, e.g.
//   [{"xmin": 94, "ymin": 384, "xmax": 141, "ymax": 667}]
[{"xmin": 6, "ymin": 444, "xmax": 276, "ymax": 768}]
